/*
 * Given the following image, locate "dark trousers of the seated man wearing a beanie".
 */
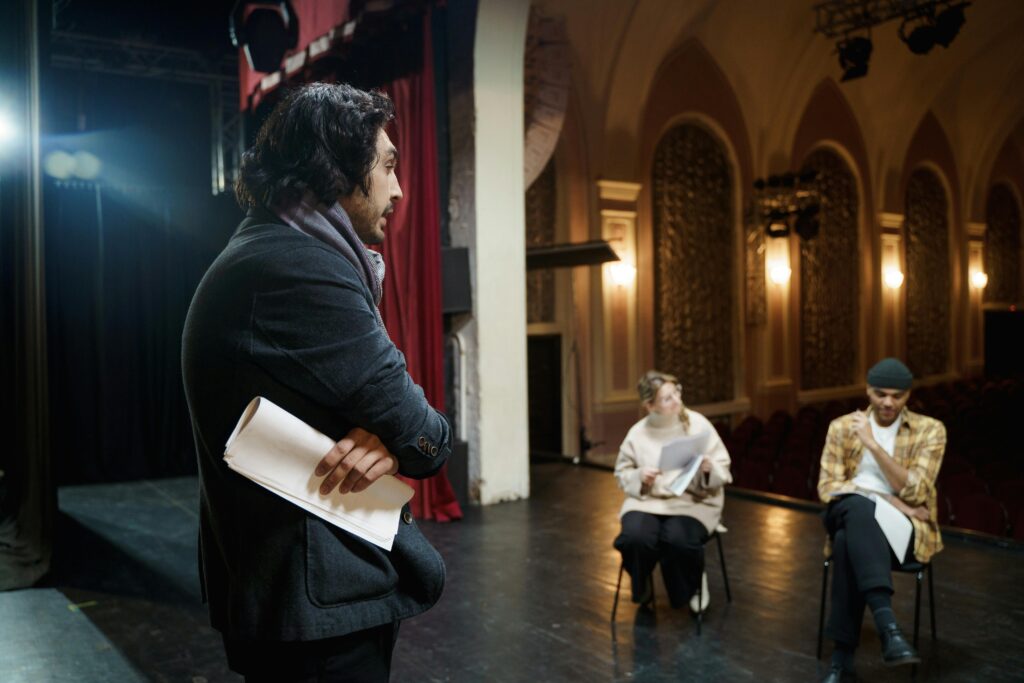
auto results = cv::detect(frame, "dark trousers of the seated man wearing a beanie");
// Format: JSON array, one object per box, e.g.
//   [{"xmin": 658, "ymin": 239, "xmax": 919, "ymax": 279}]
[{"xmin": 824, "ymin": 495, "xmax": 913, "ymax": 647}]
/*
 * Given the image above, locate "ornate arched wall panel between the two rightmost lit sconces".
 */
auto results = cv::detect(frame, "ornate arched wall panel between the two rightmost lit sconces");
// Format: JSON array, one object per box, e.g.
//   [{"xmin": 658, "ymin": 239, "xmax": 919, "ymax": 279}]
[{"xmin": 906, "ymin": 168, "xmax": 950, "ymax": 377}]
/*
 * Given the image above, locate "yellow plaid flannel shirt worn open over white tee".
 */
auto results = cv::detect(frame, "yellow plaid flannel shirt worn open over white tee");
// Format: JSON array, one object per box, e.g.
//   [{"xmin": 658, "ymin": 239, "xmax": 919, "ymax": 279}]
[{"xmin": 818, "ymin": 408, "xmax": 946, "ymax": 562}]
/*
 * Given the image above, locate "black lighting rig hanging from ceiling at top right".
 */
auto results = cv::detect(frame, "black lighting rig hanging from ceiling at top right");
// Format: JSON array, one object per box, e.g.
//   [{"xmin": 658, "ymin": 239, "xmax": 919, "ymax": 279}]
[{"xmin": 814, "ymin": 0, "xmax": 971, "ymax": 81}]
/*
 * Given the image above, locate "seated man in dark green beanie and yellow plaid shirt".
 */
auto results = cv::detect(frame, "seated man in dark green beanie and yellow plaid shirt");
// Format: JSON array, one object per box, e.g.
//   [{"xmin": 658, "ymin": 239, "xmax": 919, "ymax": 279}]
[{"xmin": 818, "ymin": 358, "xmax": 946, "ymax": 683}]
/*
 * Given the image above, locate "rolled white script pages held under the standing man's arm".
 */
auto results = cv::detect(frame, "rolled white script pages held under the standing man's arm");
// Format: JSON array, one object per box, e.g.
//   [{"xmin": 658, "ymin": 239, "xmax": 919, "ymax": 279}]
[{"xmin": 224, "ymin": 396, "xmax": 413, "ymax": 550}]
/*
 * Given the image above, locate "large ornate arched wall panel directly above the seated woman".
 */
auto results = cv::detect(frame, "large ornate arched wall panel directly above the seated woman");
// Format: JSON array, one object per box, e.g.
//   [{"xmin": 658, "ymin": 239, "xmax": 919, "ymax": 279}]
[{"xmin": 652, "ymin": 124, "xmax": 735, "ymax": 404}]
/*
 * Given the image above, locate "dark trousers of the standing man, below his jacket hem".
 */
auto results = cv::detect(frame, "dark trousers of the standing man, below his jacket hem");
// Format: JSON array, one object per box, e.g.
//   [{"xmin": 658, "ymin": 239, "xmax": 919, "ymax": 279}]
[{"xmin": 224, "ymin": 624, "xmax": 398, "ymax": 683}]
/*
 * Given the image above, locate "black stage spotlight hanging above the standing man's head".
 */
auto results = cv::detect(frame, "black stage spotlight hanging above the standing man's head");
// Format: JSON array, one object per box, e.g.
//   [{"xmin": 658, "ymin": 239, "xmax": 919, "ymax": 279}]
[{"xmin": 228, "ymin": 0, "xmax": 299, "ymax": 74}]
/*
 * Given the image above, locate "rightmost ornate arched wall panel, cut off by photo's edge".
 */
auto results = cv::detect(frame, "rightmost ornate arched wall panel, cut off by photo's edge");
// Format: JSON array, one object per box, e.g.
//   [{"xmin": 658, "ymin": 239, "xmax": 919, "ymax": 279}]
[{"xmin": 985, "ymin": 183, "xmax": 1021, "ymax": 303}]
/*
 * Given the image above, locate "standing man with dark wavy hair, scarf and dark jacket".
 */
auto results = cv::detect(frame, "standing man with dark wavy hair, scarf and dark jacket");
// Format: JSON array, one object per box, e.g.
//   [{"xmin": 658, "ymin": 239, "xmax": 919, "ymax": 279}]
[{"xmin": 182, "ymin": 84, "xmax": 452, "ymax": 682}]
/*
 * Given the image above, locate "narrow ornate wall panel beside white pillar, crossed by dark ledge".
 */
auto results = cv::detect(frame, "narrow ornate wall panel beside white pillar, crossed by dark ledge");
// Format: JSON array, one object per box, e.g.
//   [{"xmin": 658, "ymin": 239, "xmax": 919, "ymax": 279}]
[{"xmin": 526, "ymin": 160, "xmax": 557, "ymax": 323}]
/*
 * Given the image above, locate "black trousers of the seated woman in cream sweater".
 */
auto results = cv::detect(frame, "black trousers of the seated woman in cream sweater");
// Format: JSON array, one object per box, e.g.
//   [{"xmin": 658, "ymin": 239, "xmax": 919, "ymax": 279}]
[{"xmin": 614, "ymin": 511, "xmax": 709, "ymax": 607}]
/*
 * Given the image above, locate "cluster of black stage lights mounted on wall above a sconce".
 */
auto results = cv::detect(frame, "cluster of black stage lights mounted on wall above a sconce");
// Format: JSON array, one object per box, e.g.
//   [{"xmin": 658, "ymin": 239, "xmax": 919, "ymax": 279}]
[{"xmin": 754, "ymin": 171, "xmax": 822, "ymax": 240}]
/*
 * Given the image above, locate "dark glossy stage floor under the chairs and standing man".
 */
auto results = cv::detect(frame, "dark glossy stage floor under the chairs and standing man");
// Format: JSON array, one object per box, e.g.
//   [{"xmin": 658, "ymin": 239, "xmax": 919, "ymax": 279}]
[{"xmin": 0, "ymin": 464, "xmax": 1024, "ymax": 683}]
